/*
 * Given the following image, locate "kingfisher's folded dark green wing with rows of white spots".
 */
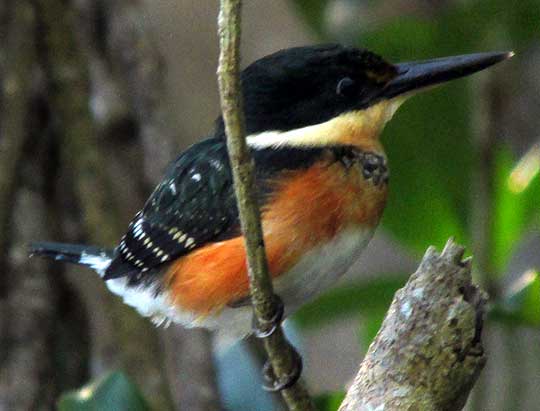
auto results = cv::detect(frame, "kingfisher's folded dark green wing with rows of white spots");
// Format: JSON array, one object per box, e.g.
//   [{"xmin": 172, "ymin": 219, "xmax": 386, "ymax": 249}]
[{"xmin": 106, "ymin": 139, "xmax": 238, "ymax": 282}]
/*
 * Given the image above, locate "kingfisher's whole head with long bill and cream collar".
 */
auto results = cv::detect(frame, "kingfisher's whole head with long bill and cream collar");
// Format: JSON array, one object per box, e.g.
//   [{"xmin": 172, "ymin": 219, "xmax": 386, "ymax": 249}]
[{"xmin": 214, "ymin": 45, "xmax": 508, "ymax": 144}]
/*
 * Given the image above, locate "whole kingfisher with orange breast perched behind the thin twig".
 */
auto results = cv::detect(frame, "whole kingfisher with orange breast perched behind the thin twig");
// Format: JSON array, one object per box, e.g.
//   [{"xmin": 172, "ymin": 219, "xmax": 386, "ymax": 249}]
[{"xmin": 31, "ymin": 44, "xmax": 512, "ymax": 360}]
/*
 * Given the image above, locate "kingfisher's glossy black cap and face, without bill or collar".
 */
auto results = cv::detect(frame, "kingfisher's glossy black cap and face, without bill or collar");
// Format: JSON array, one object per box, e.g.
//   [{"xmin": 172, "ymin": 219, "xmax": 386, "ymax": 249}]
[{"xmin": 237, "ymin": 45, "xmax": 397, "ymax": 134}]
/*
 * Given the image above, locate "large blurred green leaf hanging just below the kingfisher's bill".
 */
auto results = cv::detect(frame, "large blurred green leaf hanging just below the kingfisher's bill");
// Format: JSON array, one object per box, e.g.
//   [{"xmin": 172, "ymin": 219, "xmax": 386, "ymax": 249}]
[{"xmin": 382, "ymin": 84, "xmax": 472, "ymax": 253}]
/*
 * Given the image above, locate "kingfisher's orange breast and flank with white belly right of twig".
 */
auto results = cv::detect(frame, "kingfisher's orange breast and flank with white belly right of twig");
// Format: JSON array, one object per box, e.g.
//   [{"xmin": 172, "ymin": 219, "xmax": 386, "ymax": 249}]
[{"xmin": 165, "ymin": 161, "xmax": 386, "ymax": 323}]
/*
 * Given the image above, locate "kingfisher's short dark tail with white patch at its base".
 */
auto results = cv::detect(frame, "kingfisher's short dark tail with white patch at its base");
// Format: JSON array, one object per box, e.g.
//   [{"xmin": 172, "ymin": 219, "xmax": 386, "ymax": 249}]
[{"xmin": 30, "ymin": 242, "xmax": 114, "ymax": 276}]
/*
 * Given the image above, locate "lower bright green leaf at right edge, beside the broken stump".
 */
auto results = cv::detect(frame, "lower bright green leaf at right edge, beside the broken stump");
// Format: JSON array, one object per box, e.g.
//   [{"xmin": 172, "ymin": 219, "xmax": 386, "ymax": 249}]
[{"xmin": 489, "ymin": 270, "xmax": 540, "ymax": 327}]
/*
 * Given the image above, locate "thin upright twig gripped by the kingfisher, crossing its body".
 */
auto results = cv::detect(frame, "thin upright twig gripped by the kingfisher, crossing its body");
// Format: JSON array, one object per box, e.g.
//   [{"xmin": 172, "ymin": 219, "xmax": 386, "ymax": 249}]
[{"xmin": 218, "ymin": 0, "xmax": 313, "ymax": 411}]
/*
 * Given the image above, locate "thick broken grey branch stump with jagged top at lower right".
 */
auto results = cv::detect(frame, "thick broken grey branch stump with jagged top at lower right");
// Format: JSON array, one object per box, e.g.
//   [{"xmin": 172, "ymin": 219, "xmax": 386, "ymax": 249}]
[{"xmin": 340, "ymin": 240, "xmax": 486, "ymax": 411}]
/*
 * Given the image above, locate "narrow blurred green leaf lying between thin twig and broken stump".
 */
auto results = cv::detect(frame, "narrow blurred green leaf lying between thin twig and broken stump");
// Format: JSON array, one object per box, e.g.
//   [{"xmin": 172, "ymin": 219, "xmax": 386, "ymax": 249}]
[{"xmin": 293, "ymin": 275, "xmax": 407, "ymax": 328}]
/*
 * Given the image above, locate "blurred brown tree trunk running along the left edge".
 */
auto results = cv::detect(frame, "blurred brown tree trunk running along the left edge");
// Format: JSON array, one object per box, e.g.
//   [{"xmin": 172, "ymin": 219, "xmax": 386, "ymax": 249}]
[{"xmin": 0, "ymin": 0, "xmax": 55, "ymax": 410}]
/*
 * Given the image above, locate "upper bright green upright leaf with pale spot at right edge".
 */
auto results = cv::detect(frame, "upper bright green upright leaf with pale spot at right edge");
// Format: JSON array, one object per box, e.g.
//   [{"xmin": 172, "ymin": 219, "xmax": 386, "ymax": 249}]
[{"xmin": 492, "ymin": 146, "xmax": 540, "ymax": 272}]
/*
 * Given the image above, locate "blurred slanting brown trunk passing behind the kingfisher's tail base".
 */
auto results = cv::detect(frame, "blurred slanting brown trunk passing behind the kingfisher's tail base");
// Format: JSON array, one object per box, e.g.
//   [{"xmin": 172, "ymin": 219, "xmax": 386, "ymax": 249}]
[{"xmin": 38, "ymin": 0, "xmax": 172, "ymax": 410}]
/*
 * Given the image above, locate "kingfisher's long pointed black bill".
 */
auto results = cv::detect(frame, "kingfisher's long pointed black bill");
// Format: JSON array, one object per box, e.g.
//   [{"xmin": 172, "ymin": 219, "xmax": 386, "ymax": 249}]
[{"xmin": 382, "ymin": 52, "xmax": 514, "ymax": 98}]
